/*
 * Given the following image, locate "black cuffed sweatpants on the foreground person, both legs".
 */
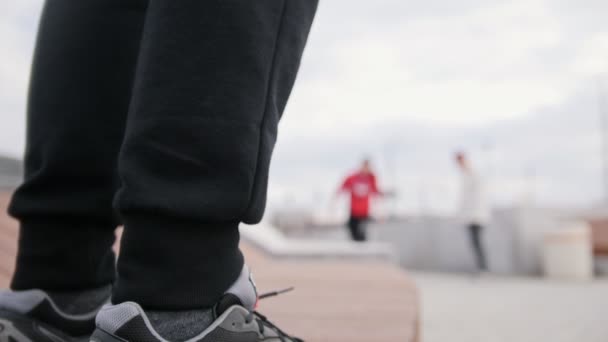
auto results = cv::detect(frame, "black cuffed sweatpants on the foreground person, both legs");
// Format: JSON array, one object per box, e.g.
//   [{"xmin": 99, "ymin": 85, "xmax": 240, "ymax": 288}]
[{"xmin": 10, "ymin": 0, "xmax": 317, "ymax": 310}]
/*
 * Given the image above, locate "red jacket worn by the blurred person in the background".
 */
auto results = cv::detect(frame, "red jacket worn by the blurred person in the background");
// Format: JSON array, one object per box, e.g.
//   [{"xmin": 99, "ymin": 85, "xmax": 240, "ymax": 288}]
[{"xmin": 340, "ymin": 171, "xmax": 380, "ymax": 218}]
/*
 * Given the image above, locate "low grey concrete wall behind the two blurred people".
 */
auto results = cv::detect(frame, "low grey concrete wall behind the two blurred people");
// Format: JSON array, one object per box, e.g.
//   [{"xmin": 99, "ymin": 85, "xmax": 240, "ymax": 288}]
[{"xmin": 300, "ymin": 208, "xmax": 584, "ymax": 275}]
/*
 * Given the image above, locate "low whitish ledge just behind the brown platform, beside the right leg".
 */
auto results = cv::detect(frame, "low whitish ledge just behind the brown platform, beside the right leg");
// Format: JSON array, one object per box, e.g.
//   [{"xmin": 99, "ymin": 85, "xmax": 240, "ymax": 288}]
[{"xmin": 241, "ymin": 223, "xmax": 397, "ymax": 262}]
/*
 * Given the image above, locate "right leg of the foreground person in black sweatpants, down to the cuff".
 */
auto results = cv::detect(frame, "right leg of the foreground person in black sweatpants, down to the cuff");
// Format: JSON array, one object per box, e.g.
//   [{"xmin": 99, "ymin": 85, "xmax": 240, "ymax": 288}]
[{"xmin": 113, "ymin": 0, "xmax": 317, "ymax": 310}]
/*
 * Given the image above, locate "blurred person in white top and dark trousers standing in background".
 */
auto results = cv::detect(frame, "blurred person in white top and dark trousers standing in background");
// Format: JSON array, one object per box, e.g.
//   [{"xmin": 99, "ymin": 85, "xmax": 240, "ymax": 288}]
[{"xmin": 455, "ymin": 152, "xmax": 490, "ymax": 271}]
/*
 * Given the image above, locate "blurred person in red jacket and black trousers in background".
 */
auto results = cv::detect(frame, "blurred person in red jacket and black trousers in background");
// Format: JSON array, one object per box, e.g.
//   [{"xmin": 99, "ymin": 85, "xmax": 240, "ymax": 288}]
[{"xmin": 338, "ymin": 159, "xmax": 382, "ymax": 242}]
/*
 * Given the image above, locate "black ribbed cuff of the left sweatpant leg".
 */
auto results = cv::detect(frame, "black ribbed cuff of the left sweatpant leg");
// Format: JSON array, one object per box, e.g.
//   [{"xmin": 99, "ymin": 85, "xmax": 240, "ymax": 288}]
[{"xmin": 11, "ymin": 219, "xmax": 116, "ymax": 291}]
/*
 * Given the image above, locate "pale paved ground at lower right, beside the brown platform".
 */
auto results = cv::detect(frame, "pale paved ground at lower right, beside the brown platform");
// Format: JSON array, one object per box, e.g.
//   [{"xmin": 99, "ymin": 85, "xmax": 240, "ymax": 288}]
[{"xmin": 413, "ymin": 273, "xmax": 608, "ymax": 342}]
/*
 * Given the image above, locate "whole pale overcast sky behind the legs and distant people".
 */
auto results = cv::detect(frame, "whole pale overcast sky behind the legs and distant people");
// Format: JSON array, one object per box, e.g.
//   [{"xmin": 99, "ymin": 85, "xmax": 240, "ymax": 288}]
[{"xmin": 0, "ymin": 0, "xmax": 608, "ymax": 211}]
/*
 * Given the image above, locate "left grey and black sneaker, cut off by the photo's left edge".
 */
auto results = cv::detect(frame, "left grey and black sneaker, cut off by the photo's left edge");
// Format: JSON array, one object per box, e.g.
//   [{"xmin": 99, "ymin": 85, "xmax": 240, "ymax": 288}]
[{"xmin": 0, "ymin": 287, "xmax": 110, "ymax": 342}]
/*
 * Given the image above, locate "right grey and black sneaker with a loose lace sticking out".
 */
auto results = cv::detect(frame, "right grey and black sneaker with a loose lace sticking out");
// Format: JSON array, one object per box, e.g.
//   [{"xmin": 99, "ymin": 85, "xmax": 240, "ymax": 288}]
[{"xmin": 90, "ymin": 267, "xmax": 303, "ymax": 342}]
